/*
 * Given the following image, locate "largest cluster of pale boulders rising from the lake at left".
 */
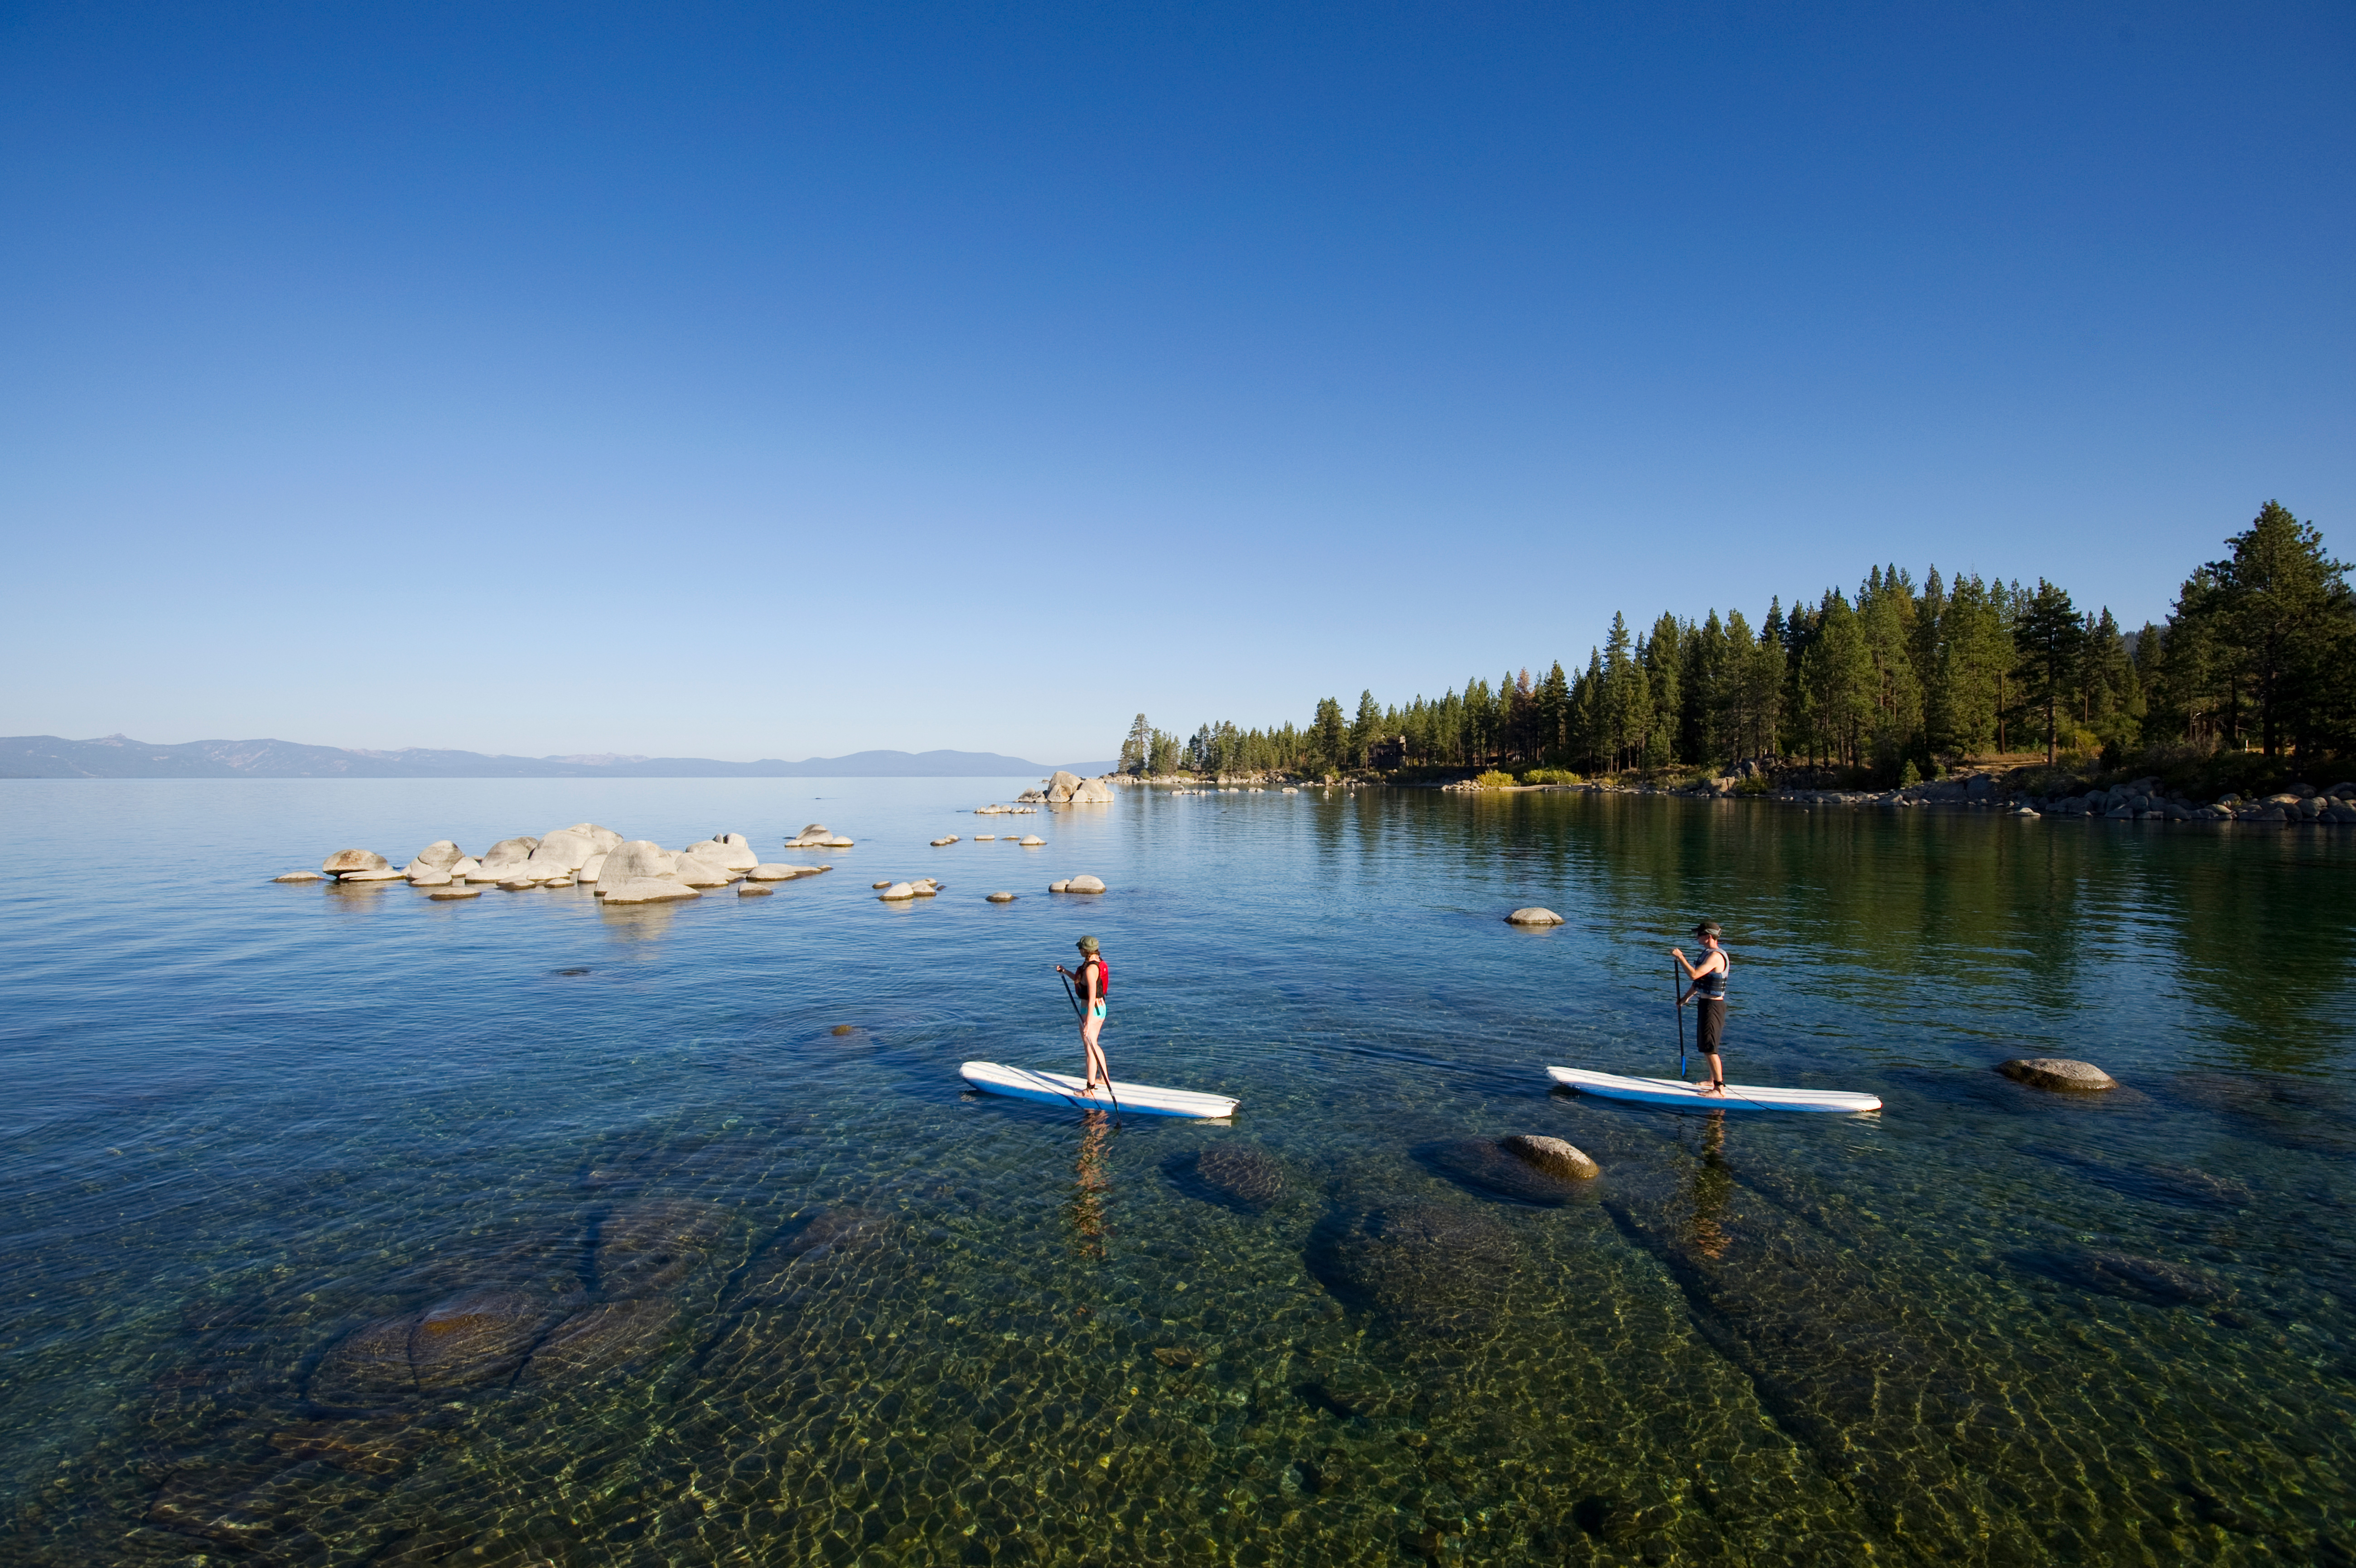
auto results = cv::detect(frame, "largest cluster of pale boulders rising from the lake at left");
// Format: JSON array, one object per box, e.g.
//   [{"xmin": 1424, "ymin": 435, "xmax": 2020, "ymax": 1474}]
[{"xmin": 278, "ymin": 822, "xmax": 848, "ymax": 904}]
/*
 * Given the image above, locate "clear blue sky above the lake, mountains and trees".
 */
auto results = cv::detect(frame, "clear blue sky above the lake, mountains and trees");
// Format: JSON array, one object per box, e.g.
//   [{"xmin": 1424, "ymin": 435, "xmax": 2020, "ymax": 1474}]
[{"xmin": 0, "ymin": 2, "xmax": 2356, "ymax": 761}]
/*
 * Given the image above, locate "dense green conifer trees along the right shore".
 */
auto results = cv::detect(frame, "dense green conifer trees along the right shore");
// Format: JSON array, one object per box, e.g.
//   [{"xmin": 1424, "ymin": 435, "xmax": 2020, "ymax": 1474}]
[{"xmin": 1119, "ymin": 502, "xmax": 2356, "ymax": 801}]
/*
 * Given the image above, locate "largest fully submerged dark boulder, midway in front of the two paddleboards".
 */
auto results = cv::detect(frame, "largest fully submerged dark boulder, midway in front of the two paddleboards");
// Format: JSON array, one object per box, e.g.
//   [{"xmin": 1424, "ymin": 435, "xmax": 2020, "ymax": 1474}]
[{"xmin": 1308, "ymin": 1203, "xmax": 1522, "ymax": 1337}]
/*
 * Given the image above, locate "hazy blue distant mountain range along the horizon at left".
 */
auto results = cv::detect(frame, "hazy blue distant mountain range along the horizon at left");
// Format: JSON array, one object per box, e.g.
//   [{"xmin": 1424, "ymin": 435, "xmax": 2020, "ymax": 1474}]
[{"xmin": 0, "ymin": 734, "xmax": 1115, "ymax": 779}]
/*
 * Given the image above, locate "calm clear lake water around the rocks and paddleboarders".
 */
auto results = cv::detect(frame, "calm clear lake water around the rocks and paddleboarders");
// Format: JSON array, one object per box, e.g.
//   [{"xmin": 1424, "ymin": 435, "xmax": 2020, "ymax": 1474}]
[{"xmin": 0, "ymin": 779, "xmax": 2356, "ymax": 1566}]
